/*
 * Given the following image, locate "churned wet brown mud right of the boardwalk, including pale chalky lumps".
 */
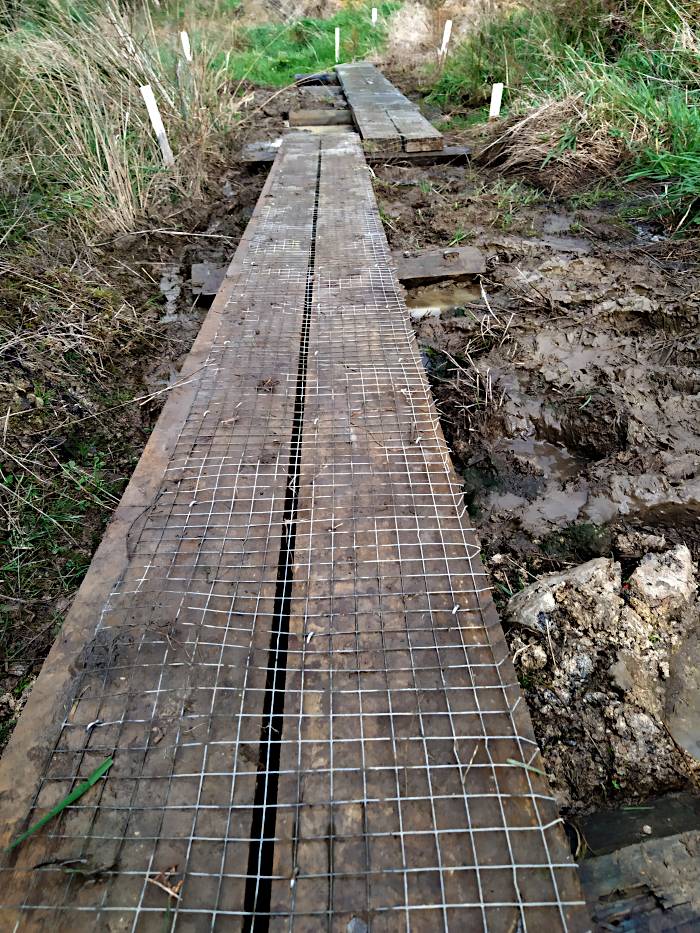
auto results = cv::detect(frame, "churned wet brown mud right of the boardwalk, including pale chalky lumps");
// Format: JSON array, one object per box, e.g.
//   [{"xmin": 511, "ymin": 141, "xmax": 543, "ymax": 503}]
[{"xmin": 375, "ymin": 118, "xmax": 700, "ymax": 813}]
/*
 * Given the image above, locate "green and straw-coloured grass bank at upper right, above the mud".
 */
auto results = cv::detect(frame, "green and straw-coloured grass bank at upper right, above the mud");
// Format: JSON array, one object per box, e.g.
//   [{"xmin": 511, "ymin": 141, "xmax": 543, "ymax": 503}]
[{"xmin": 432, "ymin": 0, "xmax": 700, "ymax": 227}]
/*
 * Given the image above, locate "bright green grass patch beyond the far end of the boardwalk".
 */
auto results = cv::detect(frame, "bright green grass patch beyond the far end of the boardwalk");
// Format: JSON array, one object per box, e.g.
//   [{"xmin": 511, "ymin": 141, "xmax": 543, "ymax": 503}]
[{"xmin": 221, "ymin": 2, "xmax": 399, "ymax": 87}]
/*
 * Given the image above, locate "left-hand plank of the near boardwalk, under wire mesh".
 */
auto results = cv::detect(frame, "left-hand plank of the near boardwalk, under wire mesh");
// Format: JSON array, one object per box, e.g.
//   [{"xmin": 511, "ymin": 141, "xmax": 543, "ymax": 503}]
[{"xmin": 0, "ymin": 133, "xmax": 319, "ymax": 931}]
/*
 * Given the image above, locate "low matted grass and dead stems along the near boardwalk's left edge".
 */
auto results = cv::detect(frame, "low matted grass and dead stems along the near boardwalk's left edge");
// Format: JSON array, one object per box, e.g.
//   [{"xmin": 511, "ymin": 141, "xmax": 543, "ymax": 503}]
[{"xmin": 0, "ymin": 244, "xmax": 163, "ymax": 750}]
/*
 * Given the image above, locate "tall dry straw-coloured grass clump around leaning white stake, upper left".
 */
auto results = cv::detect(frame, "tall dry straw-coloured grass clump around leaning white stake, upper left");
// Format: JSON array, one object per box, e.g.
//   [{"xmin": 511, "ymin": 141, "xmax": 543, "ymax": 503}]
[{"xmin": 0, "ymin": 0, "xmax": 246, "ymax": 237}]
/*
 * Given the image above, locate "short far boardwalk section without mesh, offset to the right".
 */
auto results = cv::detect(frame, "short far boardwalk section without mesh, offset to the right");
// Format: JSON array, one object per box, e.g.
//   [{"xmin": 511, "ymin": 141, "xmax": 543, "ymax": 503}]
[{"xmin": 335, "ymin": 62, "xmax": 443, "ymax": 152}]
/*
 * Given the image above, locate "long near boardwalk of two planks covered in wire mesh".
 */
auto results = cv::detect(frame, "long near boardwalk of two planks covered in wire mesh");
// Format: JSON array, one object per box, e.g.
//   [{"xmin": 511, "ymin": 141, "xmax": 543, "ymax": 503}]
[{"xmin": 0, "ymin": 133, "xmax": 587, "ymax": 933}]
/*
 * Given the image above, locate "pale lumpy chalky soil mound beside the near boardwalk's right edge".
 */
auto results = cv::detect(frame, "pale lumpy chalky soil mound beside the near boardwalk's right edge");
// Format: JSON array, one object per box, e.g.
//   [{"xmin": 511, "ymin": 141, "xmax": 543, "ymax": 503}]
[{"xmin": 504, "ymin": 545, "xmax": 700, "ymax": 811}]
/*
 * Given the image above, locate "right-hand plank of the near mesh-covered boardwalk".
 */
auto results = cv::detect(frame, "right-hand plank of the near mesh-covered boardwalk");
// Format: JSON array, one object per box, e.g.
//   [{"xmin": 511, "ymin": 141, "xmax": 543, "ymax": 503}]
[{"xmin": 270, "ymin": 134, "xmax": 587, "ymax": 933}]
